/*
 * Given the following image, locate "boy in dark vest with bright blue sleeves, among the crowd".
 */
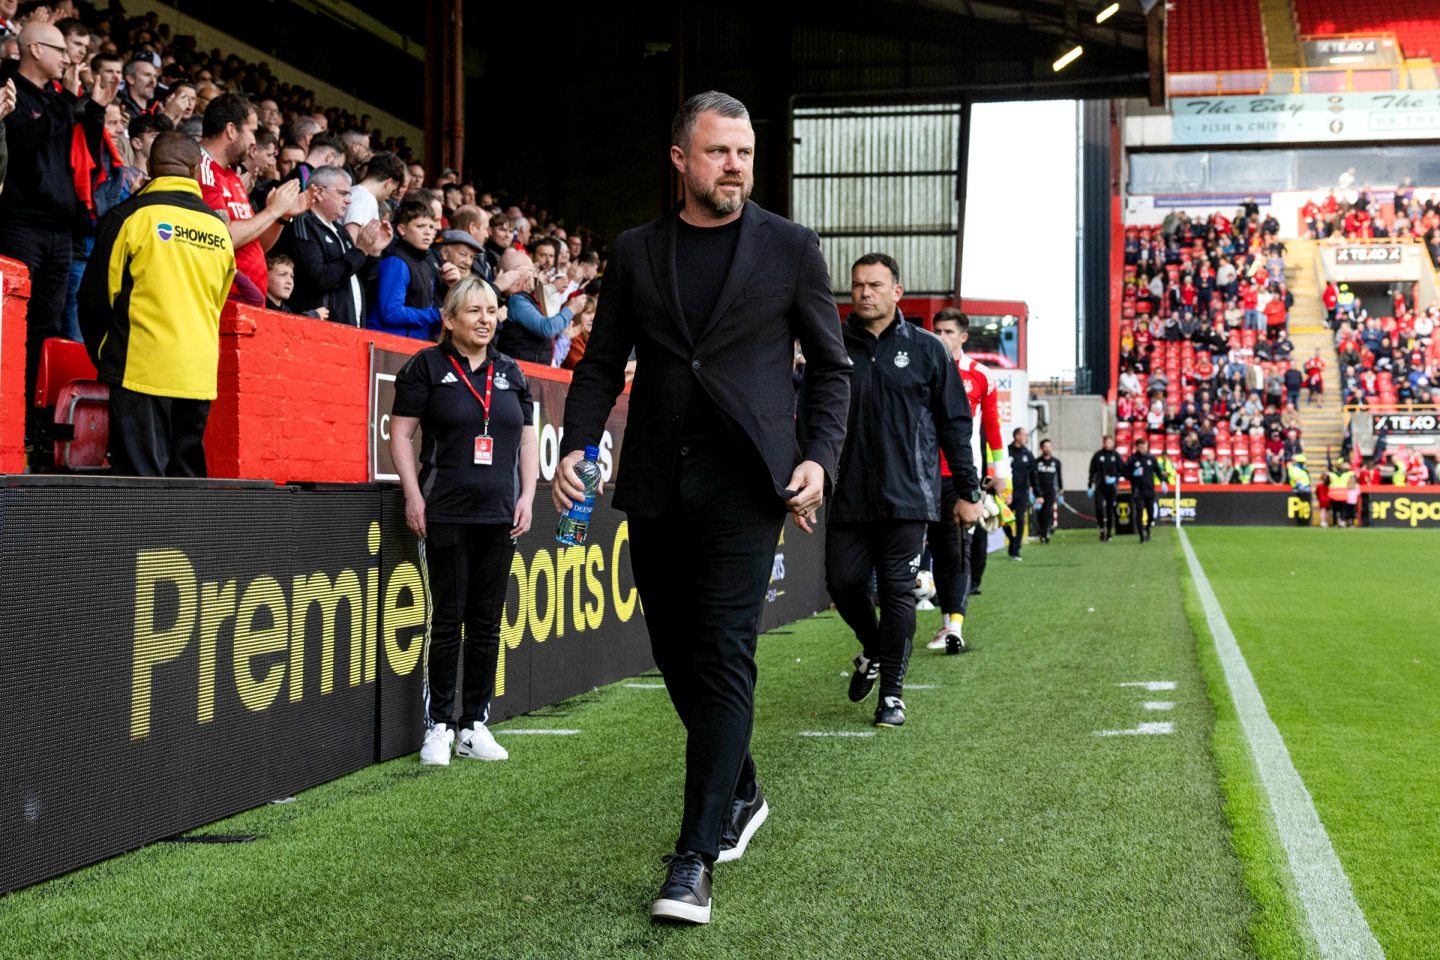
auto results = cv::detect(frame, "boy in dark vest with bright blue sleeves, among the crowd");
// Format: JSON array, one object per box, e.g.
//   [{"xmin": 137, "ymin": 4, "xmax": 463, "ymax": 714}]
[{"xmin": 366, "ymin": 200, "xmax": 441, "ymax": 340}]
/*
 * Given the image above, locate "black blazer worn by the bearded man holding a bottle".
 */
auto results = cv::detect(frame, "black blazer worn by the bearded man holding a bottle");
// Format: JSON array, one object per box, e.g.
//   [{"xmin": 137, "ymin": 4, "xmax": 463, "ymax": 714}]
[{"xmin": 560, "ymin": 201, "xmax": 851, "ymax": 517}]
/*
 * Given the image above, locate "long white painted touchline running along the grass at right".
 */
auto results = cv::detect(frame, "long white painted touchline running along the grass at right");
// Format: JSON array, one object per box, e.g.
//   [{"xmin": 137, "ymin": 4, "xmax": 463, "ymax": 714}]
[{"xmin": 1178, "ymin": 528, "xmax": 1385, "ymax": 960}]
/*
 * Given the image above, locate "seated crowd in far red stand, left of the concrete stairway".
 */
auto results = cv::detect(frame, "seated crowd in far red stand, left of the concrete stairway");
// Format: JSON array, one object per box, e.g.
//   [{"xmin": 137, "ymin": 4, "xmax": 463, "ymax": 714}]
[{"xmin": 1115, "ymin": 200, "xmax": 1319, "ymax": 484}]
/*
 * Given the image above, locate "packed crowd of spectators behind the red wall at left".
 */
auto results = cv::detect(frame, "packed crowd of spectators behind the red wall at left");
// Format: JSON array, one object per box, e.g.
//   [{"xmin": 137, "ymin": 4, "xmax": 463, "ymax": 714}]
[{"xmin": 0, "ymin": 0, "xmax": 600, "ymax": 460}]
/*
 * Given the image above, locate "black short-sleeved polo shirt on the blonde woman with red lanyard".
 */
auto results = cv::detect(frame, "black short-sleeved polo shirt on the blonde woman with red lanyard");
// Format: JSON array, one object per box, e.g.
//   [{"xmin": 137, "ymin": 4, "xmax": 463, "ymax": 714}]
[{"xmin": 390, "ymin": 344, "xmax": 534, "ymax": 525}]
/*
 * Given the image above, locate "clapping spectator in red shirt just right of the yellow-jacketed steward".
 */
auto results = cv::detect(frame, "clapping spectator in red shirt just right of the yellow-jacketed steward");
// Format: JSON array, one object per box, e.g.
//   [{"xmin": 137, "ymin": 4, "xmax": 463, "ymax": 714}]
[{"xmin": 199, "ymin": 94, "xmax": 310, "ymax": 305}]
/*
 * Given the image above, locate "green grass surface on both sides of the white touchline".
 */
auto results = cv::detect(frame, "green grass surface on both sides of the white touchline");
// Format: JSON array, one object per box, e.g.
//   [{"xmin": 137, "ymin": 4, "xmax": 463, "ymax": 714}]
[{"xmin": 0, "ymin": 530, "xmax": 1416, "ymax": 960}]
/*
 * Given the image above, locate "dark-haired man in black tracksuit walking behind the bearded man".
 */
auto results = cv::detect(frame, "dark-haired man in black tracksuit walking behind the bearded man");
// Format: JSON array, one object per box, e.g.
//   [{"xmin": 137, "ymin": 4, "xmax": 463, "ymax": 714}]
[{"xmin": 825, "ymin": 253, "xmax": 981, "ymax": 727}]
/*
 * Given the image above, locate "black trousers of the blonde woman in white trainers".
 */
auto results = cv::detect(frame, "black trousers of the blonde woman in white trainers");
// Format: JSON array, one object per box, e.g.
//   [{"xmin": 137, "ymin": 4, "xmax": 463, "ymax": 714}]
[{"xmin": 420, "ymin": 524, "xmax": 516, "ymax": 728}]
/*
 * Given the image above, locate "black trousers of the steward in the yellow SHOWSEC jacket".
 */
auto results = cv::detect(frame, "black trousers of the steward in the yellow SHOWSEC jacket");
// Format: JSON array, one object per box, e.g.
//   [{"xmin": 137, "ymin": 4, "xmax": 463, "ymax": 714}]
[{"xmin": 109, "ymin": 384, "xmax": 210, "ymax": 476}]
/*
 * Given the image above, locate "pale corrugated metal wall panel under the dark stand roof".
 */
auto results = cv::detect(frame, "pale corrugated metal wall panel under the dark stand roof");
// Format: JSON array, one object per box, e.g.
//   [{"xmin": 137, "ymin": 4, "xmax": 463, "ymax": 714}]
[{"xmin": 791, "ymin": 104, "xmax": 960, "ymax": 295}]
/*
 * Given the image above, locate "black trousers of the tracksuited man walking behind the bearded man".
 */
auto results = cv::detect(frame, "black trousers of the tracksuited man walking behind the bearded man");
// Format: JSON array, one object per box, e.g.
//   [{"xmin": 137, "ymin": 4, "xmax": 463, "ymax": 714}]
[{"xmin": 825, "ymin": 520, "xmax": 926, "ymax": 697}]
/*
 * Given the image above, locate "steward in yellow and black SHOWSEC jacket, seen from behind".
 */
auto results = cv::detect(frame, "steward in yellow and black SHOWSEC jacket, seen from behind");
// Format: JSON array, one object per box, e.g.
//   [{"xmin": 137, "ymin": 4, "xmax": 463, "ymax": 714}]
[{"xmin": 78, "ymin": 132, "xmax": 235, "ymax": 476}]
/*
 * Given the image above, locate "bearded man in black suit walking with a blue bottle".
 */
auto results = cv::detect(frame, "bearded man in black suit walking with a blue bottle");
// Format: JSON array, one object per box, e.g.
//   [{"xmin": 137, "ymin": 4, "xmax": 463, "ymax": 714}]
[{"xmin": 554, "ymin": 91, "xmax": 850, "ymax": 923}]
